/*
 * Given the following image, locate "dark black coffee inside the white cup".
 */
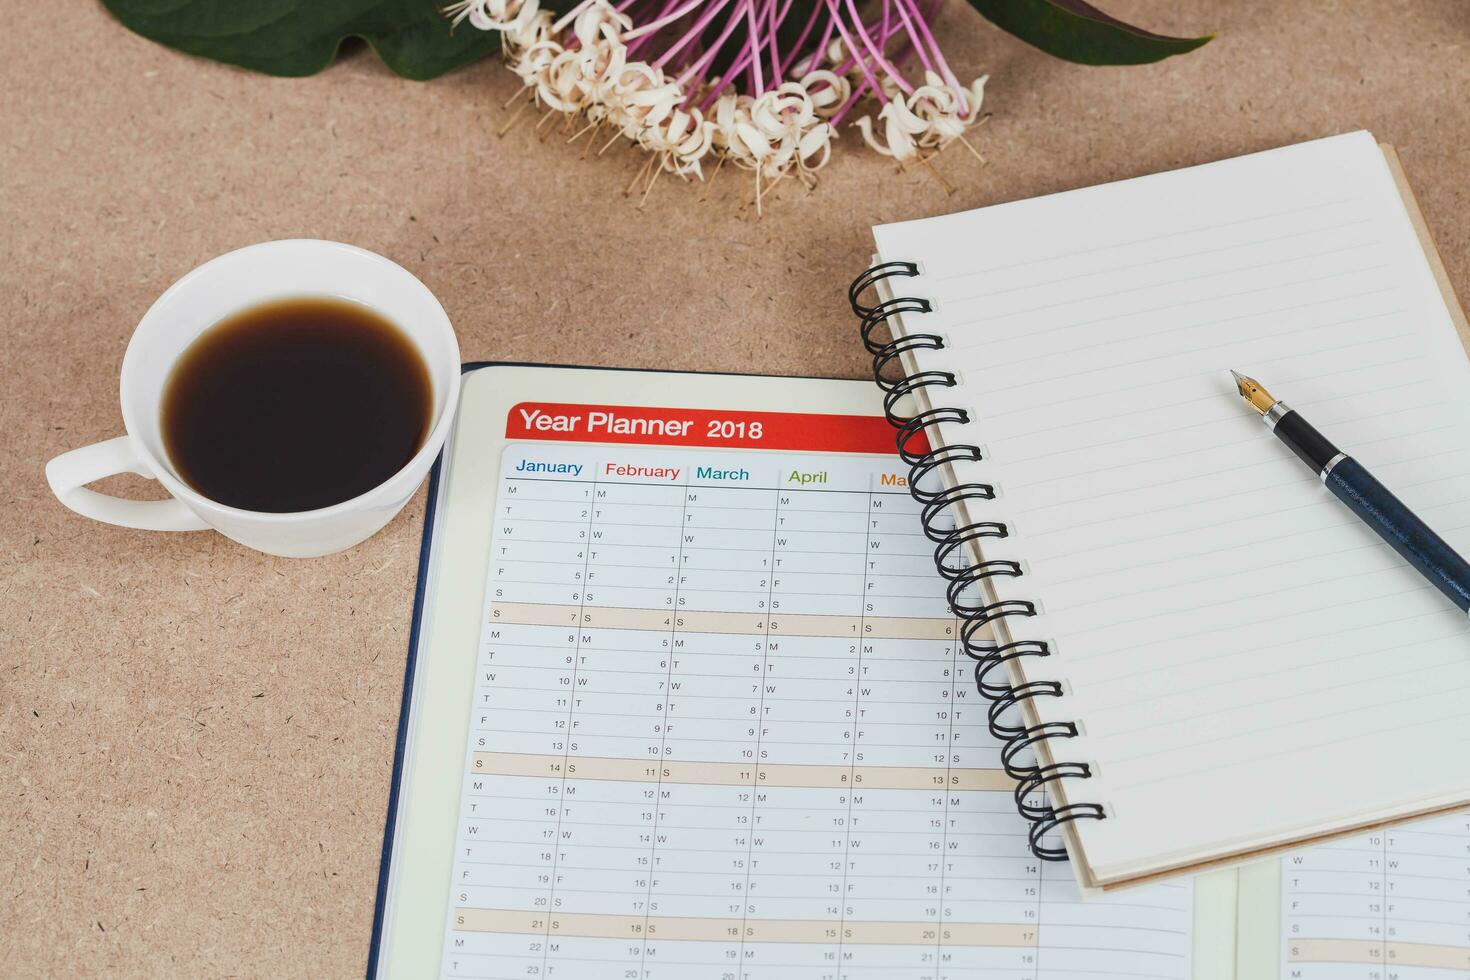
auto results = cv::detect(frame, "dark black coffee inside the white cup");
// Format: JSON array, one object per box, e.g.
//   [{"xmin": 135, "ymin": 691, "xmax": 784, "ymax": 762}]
[{"xmin": 162, "ymin": 298, "xmax": 434, "ymax": 513}]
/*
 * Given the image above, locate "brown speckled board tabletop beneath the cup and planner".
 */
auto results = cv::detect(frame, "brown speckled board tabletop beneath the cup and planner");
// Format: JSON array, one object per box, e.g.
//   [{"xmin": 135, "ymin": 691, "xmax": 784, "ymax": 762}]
[{"xmin": 0, "ymin": 0, "xmax": 1470, "ymax": 977}]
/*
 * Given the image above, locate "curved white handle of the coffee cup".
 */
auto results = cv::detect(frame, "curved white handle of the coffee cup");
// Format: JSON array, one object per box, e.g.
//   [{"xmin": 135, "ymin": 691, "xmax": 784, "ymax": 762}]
[{"xmin": 46, "ymin": 435, "xmax": 209, "ymax": 530}]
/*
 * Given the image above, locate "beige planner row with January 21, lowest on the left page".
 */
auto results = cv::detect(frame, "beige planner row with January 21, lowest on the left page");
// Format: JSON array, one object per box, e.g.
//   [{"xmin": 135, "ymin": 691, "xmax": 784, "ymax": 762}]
[{"xmin": 454, "ymin": 908, "xmax": 1036, "ymax": 946}]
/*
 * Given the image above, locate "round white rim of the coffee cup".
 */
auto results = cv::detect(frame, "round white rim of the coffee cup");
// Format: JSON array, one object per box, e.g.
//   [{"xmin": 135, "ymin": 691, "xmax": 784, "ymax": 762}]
[{"xmin": 118, "ymin": 238, "xmax": 460, "ymax": 525}]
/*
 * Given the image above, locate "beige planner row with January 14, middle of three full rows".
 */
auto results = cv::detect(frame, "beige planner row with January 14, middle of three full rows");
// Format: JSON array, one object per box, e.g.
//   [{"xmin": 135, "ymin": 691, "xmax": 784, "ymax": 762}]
[{"xmin": 470, "ymin": 752, "xmax": 1016, "ymax": 792}]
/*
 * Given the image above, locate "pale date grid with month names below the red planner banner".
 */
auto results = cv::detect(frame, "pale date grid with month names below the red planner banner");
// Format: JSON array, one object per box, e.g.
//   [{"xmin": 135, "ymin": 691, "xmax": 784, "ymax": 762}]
[{"xmin": 442, "ymin": 444, "xmax": 1189, "ymax": 980}]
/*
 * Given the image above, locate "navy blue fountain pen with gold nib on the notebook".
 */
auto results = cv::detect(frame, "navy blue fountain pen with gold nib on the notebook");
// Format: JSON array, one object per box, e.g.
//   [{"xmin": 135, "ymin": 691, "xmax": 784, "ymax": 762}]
[{"xmin": 1230, "ymin": 370, "xmax": 1470, "ymax": 613}]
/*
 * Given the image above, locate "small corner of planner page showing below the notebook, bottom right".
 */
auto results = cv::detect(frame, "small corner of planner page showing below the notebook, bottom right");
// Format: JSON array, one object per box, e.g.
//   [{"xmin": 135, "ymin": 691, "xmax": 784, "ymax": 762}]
[{"xmin": 1280, "ymin": 814, "xmax": 1470, "ymax": 980}]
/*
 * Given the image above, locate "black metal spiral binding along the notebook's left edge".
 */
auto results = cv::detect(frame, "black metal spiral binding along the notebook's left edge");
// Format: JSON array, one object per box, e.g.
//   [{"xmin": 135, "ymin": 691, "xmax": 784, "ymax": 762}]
[{"xmin": 847, "ymin": 262, "xmax": 1107, "ymax": 861}]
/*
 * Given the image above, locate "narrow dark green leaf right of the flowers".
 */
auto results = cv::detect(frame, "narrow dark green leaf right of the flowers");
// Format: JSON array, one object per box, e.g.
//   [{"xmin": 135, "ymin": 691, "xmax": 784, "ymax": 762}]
[{"xmin": 970, "ymin": 0, "xmax": 1214, "ymax": 65}]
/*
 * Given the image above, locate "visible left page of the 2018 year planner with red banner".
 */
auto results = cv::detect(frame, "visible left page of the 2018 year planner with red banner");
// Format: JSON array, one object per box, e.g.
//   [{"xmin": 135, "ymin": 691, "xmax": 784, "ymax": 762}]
[{"xmin": 368, "ymin": 364, "xmax": 1205, "ymax": 980}]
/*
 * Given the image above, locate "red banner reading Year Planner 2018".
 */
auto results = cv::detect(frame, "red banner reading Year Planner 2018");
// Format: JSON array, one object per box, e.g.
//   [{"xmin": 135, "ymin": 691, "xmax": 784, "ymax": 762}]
[{"xmin": 506, "ymin": 401, "xmax": 922, "ymax": 455}]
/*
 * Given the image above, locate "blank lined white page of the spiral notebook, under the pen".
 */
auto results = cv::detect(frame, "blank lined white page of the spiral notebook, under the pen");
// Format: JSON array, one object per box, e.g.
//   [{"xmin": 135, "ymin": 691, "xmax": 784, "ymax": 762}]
[{"xmin": 876, "ymin": 132, "xmax": 1470, "ymax": 883}]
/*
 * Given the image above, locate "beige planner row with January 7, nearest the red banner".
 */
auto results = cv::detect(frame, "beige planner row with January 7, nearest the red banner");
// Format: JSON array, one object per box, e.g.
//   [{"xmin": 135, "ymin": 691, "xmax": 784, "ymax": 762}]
[{"xmin": 490, "ymin": 602, "xmax": 956, "ymax": 639}]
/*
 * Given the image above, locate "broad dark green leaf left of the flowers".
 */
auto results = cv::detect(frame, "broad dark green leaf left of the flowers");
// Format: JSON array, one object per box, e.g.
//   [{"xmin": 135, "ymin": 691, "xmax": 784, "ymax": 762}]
[{"xmin": 103, "ymin": 0, "xmax": 500, "ymax": 79}]
